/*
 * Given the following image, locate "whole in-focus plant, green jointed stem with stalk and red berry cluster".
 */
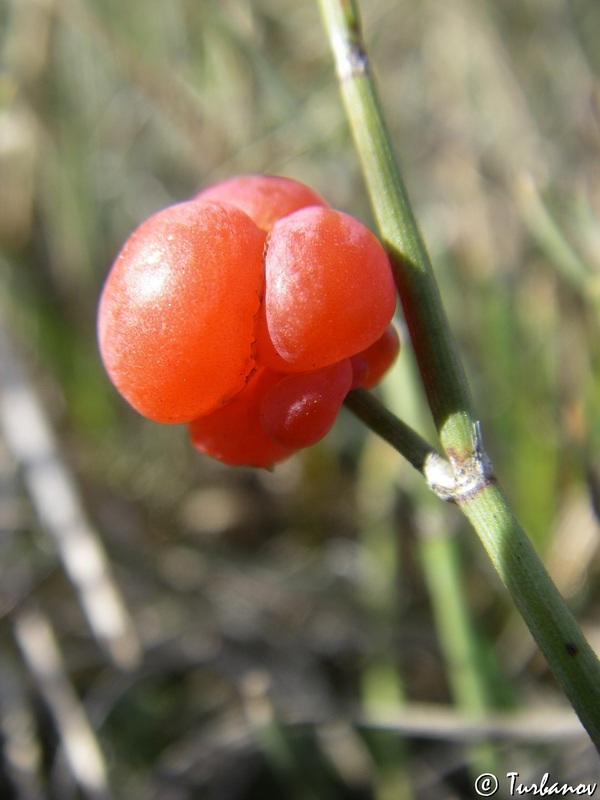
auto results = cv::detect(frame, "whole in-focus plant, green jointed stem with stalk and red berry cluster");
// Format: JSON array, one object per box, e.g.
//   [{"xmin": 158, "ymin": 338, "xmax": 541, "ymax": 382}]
[{"xmin": 99, "ymin": 0, "xmax": 600, "ymax": 748}]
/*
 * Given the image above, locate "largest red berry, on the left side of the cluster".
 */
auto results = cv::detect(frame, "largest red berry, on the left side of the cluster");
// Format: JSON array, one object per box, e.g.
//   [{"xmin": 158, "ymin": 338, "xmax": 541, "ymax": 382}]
[{"xmin": 98, "ymin": 201, "xmax": 265, "ymax": 422}]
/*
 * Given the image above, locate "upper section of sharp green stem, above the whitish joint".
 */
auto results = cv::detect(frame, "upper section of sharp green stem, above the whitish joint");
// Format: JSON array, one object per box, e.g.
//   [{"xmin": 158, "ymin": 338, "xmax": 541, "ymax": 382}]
[{"xmin": 320, "ymin": 0, "xmax": 473, "ymax": 459}]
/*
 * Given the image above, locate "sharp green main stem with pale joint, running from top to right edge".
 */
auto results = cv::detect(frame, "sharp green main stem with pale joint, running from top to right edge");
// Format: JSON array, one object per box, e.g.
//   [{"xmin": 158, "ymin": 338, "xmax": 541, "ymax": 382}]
[{"xmin": 320, "ymin": 0, "xmax": 600, "ymax": 750}]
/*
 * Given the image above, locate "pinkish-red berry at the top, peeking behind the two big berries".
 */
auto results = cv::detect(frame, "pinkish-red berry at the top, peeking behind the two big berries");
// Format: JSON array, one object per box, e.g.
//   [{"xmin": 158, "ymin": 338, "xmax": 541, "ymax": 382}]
[{"xmin": 196, "ymin": 175, "xmax": 327, "ymax": 231}]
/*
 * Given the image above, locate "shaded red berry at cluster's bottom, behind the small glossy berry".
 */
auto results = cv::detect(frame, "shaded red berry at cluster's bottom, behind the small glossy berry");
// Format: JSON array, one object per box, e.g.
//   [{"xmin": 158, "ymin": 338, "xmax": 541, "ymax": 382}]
[{"xmin": 189, "ymin": 369, "xmax": 293, "ymax": 467}]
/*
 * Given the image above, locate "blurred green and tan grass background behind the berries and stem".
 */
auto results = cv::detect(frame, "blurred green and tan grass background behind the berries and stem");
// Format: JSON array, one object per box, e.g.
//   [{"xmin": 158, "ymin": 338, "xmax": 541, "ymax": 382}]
[{"xmin": 0, "ymin": 0, "xmax": 600, "ymax": 800}]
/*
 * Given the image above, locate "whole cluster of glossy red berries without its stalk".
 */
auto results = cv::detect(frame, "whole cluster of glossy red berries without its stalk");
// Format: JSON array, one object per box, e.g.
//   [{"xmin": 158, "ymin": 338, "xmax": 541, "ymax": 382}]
[{"xmin": 98, "ymin": 175, "xmax": 399, "ymax": 467}]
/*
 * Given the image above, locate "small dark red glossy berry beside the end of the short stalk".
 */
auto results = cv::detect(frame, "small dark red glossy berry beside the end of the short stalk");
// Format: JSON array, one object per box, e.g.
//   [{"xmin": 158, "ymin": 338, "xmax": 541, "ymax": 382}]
[{"xmin": 260, "ymin": 359, "xmax": 352, "ymax": 449}]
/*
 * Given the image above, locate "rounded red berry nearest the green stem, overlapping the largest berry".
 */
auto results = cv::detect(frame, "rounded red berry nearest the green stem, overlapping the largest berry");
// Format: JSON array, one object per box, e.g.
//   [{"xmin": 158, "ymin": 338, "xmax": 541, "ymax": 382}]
[{"xmin": 256, "ymin": 206, "xmax": 396, "ymax": 372}]
